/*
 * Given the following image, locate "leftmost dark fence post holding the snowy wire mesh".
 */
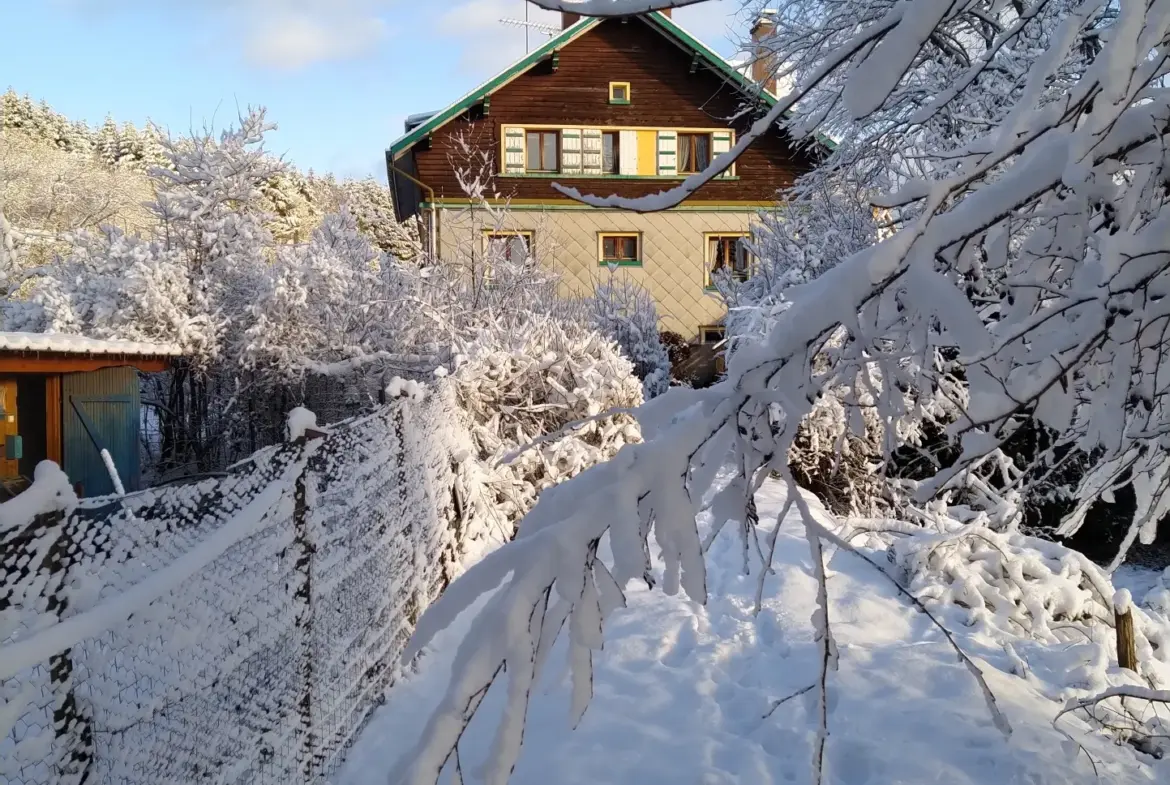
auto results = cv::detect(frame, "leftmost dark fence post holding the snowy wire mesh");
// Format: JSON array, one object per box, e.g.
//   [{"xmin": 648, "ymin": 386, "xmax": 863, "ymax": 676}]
[{"xmin": 33, "ymin": 510, "xmax": 94, "ymax": 783}]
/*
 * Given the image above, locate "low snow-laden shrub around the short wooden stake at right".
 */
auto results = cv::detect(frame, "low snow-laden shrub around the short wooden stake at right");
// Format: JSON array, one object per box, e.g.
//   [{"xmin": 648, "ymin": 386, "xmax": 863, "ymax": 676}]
[{"xmin": 842, "ymin": 510, "xmax": 1170, "ymax": 753}]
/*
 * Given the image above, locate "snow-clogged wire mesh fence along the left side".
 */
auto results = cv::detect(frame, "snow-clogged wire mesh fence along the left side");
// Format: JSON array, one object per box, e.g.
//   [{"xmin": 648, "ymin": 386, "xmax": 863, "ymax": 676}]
[{"xmin": 0, "ymin": 379, "xmax": 484, "ymax": 785}]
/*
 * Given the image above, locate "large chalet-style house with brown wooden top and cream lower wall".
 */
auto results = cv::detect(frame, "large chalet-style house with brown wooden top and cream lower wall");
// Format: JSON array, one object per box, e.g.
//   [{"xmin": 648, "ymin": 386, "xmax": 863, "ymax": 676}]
[{"xmin": 386, "ymin": 11, "xmax": 818, "ymax": 355}]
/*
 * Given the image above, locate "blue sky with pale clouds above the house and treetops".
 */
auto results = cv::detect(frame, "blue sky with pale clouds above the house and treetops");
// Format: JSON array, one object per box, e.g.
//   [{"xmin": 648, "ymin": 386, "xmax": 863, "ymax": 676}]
[{"xmin": 0, "ymin": 0, "xmax": 743, "ymax": 177}]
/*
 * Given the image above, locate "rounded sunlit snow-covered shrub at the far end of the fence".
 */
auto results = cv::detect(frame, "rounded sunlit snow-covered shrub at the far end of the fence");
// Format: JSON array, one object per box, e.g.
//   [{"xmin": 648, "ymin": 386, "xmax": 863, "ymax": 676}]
[{"xmin": 452, "ymin": 316, "xmax": 642, "ymax": 521}]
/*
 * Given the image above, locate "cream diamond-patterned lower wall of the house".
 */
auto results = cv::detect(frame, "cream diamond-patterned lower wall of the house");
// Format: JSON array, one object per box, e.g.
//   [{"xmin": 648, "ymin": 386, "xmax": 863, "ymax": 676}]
[{"xmin": 438, "ymin": 207, "xmax": 756, "ymax": 340}]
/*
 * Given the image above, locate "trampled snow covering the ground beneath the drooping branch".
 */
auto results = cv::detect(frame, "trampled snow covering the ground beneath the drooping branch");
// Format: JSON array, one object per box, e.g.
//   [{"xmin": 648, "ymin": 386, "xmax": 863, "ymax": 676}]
[{"xmin": 336, "ymin": 483, "xmax": 1170, "ymax": 785}]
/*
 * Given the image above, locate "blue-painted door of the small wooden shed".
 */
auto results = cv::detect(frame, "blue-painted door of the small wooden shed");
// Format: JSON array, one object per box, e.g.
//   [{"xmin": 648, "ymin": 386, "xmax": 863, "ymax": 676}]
[{"xmin": 61, "ymin": 367, "xmax": 142, "ymax": 496}]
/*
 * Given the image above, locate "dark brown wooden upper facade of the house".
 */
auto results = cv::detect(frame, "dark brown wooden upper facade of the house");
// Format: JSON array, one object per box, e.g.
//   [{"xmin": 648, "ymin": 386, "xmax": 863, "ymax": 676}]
[{"xmin": 395, "ymin": 18, "xmax": 814, "ymax": 212}]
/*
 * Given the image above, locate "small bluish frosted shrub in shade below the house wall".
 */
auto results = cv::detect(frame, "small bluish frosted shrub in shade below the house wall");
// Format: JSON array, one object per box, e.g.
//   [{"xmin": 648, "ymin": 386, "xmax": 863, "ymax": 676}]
[{"xmin": 586, "ymin": 275, "xmax": 670, "ymax": 400}]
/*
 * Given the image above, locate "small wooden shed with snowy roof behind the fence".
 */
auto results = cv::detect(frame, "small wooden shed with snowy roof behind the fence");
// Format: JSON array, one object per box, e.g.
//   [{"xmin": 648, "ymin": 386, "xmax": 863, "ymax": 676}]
[{"xmin": 0, "ymin": 332, "xmax": 179, "ymax": 496}]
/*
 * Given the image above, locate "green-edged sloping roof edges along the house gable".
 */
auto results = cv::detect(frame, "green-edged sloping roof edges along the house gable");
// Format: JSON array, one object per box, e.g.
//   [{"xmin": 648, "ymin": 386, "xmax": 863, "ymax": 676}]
[{"xmin": 386, "ymin": 11, "xmax": 827, "ymax": 160}]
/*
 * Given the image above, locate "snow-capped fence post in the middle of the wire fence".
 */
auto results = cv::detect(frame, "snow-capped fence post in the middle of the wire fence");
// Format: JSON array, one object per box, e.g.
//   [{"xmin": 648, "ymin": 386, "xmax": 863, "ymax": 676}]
[{"xmin": 293, "ymin": 428, "xmax": 325, "ymax": 784}]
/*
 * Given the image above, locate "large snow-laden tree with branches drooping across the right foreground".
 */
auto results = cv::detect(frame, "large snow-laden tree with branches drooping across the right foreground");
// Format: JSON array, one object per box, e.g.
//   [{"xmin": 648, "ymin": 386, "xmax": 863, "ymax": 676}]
[{"xmin": 401, "ymin": 0, "xmax": 1170, "ymax": 785}]
